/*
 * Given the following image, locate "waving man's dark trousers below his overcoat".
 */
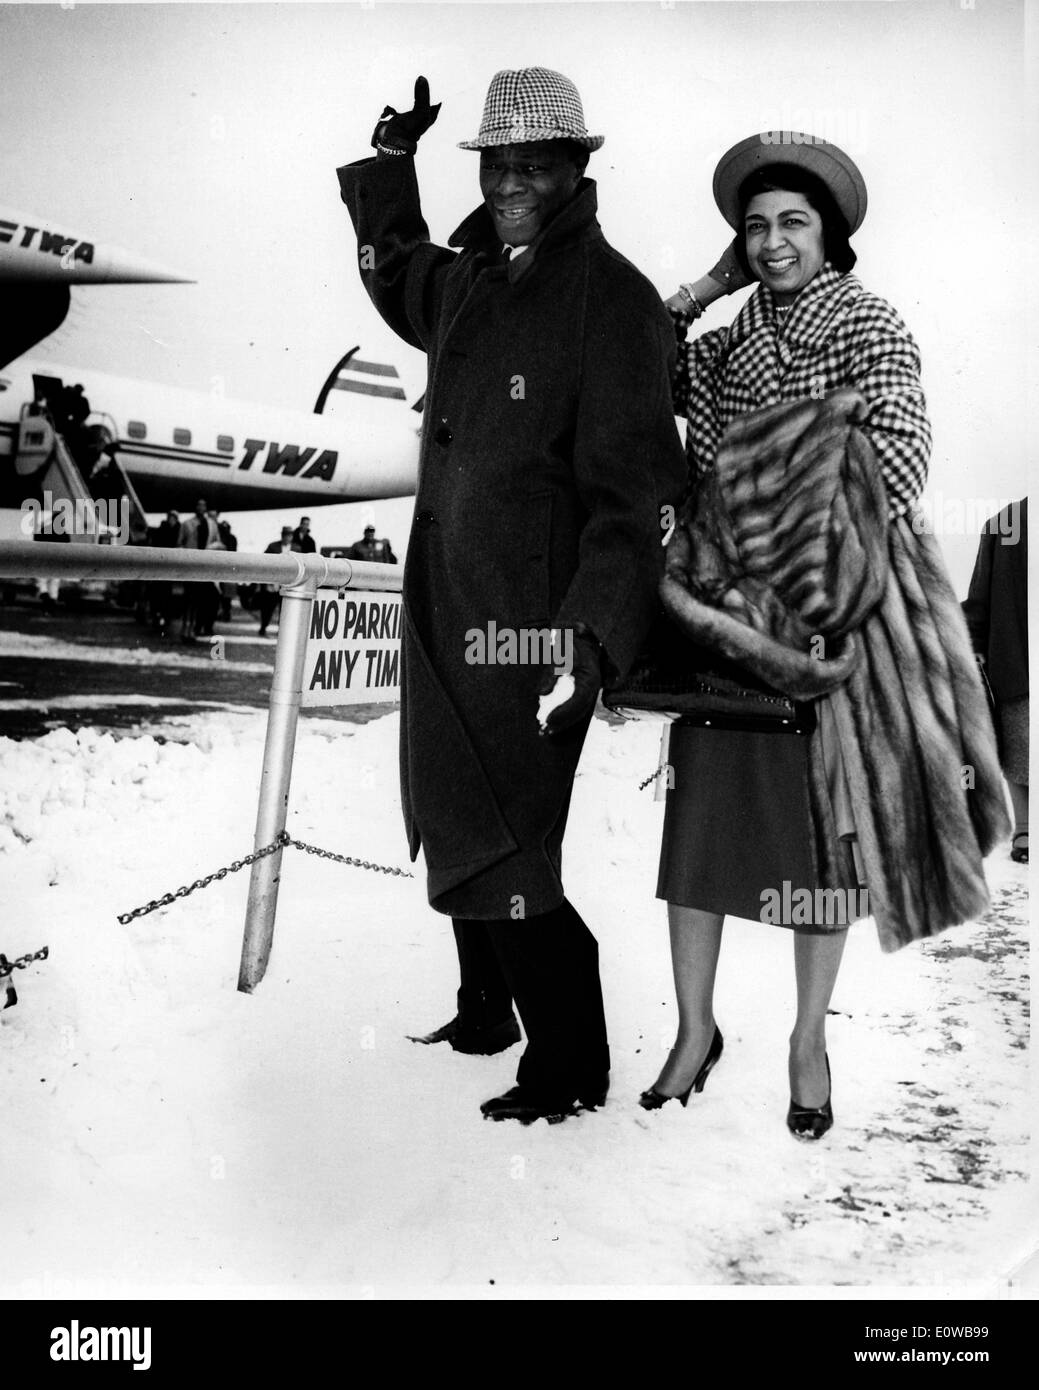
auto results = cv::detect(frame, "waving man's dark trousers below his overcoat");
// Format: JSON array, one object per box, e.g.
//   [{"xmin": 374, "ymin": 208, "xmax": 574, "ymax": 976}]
[{"xmin": 453, "ymin": 899, "xmax": 609, "ymax": 1104}]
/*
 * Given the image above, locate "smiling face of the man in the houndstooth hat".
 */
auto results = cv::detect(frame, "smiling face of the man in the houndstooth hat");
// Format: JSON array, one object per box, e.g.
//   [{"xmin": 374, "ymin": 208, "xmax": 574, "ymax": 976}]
[{"xmin": 480, "ymin": 140, "xmax": 581, "ymax": 246}]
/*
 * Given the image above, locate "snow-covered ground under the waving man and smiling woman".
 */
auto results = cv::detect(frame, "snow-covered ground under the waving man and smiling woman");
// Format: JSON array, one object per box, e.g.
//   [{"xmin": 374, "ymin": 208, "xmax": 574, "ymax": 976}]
[{"xmin": 0, "ymin": 710, "xmax": 1039, "ymax": 1297}]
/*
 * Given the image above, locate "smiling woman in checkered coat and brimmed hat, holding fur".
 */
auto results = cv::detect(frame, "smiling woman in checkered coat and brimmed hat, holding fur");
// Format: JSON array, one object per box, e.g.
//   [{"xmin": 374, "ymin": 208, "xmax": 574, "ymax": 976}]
[{"xmin": 641, "ymin": 132, "xmax": 1006, "ymax": 1138}]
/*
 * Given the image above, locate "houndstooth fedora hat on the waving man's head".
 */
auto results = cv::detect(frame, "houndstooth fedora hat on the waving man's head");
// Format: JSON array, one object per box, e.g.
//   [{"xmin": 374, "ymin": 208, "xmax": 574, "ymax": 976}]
[{"xmin": 458, "ymin": 68, "xmax": 605, "ymax": 150}]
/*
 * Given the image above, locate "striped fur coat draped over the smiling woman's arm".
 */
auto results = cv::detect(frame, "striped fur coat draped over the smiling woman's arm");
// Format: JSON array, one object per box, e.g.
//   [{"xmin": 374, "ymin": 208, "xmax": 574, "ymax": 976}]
[{"xmin": 661, "ymin": 389, "xmax": 1008, "ymax": 951}]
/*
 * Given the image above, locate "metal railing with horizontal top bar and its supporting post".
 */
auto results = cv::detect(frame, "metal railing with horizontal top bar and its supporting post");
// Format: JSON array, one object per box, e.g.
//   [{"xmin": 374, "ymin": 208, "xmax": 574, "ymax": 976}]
[{"xmin": 0, "ymin": 541, "xmax": 403, "ymax": 994}]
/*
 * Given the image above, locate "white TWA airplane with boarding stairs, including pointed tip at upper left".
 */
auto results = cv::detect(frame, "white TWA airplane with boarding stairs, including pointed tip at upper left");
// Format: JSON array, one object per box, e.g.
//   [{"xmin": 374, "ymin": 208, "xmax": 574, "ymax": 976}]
[{"xmin": 0, "ymin": 209, "xmax": 421, "ymax": 512}]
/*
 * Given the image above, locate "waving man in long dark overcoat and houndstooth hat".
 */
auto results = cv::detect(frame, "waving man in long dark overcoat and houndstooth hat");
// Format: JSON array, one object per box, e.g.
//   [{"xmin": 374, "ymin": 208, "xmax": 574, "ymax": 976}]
[{"xmin": 338, "ymin": 68, "xmax": 684, "ymax": 1122}]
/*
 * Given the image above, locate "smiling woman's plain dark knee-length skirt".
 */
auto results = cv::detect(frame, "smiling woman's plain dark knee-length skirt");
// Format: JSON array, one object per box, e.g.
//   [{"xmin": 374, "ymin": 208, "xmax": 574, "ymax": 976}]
[{"xmin": 657, "ymin": 724, "xmax": 832, "ymax": 931}]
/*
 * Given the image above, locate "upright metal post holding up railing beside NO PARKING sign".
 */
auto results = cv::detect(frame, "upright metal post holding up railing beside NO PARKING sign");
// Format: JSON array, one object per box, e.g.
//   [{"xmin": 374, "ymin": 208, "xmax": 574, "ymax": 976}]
[{"xmin": 238, "ymin": 578, "xmax": 317, "ymax": 994}]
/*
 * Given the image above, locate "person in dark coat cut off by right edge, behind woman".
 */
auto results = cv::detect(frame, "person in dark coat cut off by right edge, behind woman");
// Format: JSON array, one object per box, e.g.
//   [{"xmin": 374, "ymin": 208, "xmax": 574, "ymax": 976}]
[{"xmin": 964, "ymin": 498, "xmax": 1028, "ymax": 863}]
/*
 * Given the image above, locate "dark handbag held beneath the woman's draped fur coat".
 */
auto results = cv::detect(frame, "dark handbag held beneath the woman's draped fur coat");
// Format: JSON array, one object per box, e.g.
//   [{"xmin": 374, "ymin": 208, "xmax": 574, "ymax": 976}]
[{"xmin": 602, "ymin": 610, "xmax": 815, "ymax": 734}]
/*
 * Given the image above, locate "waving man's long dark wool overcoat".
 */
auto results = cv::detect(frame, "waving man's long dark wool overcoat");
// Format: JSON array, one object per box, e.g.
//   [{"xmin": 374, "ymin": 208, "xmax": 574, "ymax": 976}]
[{"xmin": 338, "ymin": 157, "xmax": 684, "ymax": 920}]
